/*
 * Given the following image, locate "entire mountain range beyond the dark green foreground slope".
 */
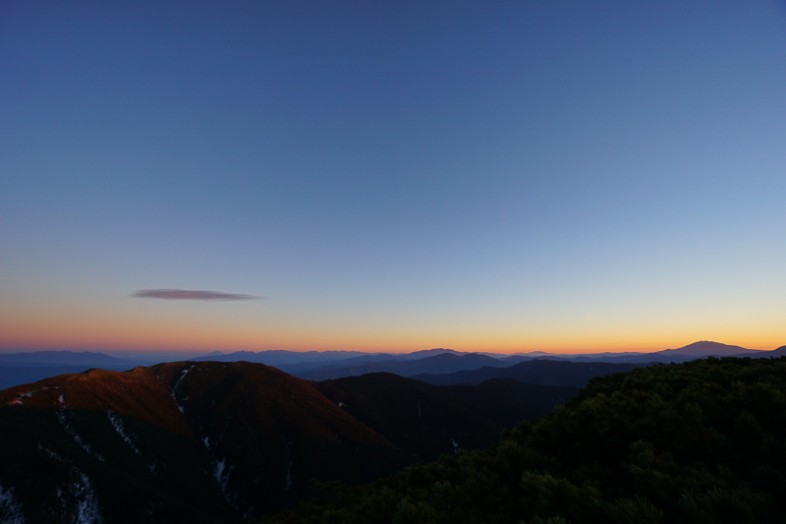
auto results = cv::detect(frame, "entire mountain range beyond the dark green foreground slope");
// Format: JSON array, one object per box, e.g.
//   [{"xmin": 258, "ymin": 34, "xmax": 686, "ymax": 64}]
[{"xmin": 0, "ymin": 342, "xmax": 786, "ymax": 522}]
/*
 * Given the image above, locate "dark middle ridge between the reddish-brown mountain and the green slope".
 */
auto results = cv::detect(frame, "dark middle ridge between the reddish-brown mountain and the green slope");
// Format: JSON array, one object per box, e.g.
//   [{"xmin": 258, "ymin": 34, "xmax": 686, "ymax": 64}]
[{"xmin": 317, "ymin": 373, "xmax": 578, "ymax": 460}]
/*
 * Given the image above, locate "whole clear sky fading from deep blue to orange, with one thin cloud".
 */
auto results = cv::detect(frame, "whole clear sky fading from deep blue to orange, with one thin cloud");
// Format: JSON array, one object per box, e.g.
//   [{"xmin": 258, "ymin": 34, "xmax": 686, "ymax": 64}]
[{"xmin": 0, "ymin": 0, "xmax": 786, "ymax": 352}]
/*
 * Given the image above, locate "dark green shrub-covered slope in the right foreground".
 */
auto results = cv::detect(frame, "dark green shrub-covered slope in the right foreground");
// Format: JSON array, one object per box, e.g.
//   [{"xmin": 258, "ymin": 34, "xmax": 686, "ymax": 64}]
[{"xmin": 265, "ymin": 358, "xmax": 786, "ymax": 524}]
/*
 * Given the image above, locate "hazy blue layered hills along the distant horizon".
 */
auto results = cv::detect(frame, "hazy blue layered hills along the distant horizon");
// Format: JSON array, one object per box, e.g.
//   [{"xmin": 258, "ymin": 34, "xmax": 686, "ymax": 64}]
[{"xmin": 0, "ymin": 341, "xmax": 786, "ymax": 389}]
